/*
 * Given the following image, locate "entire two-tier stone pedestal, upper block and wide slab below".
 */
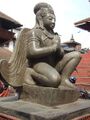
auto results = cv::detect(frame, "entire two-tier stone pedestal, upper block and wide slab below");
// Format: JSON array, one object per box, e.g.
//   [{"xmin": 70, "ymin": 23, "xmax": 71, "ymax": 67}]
[{"xmin": 0, "ymin": 85, "xmax": 90, "ymax": 120}]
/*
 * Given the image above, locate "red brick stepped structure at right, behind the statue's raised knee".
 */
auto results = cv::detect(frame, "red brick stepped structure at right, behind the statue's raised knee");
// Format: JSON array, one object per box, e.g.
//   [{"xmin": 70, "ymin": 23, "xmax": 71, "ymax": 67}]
[{"xmin": 72, "ymin": 50, "xmax": 90, "ymax": 90}]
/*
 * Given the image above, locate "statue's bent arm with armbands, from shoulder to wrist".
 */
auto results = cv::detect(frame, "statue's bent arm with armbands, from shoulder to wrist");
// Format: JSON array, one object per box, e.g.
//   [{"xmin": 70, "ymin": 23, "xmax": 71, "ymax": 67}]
[{"xmin": 28, "ymin": 30, "xmax": 57, "ymax": 58}]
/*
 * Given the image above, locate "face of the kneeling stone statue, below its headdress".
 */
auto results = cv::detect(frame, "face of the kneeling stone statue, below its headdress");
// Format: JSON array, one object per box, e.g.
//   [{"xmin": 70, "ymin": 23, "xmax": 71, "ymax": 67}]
[{"xmin": 43, "ymin": 13, "xmax": 55, "ymax": 29}]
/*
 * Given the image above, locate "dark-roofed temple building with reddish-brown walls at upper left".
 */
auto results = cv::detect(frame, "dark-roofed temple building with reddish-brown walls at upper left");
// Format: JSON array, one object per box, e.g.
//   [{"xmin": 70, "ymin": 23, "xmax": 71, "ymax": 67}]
[{"xmin": 0, "ymin": 12, "xmax": 22, "ymax": 46}]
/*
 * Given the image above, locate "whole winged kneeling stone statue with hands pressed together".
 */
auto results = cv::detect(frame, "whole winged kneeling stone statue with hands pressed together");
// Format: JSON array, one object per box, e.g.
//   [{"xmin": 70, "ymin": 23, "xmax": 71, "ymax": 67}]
[{"xmin": 0, "ymin": 3, "xmax": 81, "ymax": 88}]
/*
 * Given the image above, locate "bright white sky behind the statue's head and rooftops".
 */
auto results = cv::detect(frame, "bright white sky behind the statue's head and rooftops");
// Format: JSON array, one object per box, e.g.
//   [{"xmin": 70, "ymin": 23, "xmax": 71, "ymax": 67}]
[{"xmin": 0, "ymin": 0, "xmax": 90, "ymax": 48}]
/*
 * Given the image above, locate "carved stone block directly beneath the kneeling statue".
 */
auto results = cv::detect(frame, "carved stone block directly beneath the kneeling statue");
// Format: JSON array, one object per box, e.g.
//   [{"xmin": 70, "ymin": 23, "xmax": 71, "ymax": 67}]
[{"xmin": 21, "ymin": 84, "xmax": 79, "ymax": 106}]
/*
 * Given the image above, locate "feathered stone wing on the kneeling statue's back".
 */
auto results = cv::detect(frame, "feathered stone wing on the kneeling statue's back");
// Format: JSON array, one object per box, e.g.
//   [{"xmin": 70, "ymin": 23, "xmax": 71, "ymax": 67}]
[{"xmin": 0, "ymin": 28, "xmax": 30, "ymax": 86}]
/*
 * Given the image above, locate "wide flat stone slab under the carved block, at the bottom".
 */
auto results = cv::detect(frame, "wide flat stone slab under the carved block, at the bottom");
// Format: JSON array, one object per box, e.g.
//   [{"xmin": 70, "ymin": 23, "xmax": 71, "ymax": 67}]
[{"xmin": 0, "ymin": 99, "xmax": 90, "ymax": 120}]
